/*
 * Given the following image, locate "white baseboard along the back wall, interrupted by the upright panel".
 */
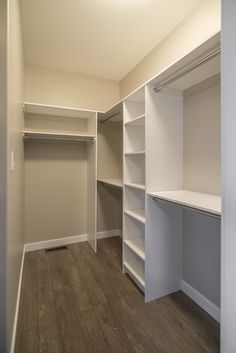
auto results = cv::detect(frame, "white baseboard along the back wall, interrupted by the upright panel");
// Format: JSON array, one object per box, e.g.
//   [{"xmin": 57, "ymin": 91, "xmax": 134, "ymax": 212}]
[{"xmin": 25, "ymin": 229, "xmax": 121, "ymax": 252}]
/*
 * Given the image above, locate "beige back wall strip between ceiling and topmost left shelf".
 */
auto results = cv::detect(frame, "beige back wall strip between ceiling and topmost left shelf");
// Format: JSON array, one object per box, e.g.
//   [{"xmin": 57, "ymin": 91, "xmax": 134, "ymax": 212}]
[{"xmin": 25, "ymin": 65, "xmax": 119, "ymax": 111}]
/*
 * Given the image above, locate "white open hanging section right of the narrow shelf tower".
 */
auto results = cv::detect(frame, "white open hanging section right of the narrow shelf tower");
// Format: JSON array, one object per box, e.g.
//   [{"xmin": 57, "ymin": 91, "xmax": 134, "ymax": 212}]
[{"xmin": 145, "ymin": 44, "xmax": 221, "ymax": 320}]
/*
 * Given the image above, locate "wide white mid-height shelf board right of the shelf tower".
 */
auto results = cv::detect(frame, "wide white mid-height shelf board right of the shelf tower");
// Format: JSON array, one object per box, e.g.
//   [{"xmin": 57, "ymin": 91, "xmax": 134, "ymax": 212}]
[{"xmin": 148, "ymin": 190, "xmax": 221, "ymax": 216}]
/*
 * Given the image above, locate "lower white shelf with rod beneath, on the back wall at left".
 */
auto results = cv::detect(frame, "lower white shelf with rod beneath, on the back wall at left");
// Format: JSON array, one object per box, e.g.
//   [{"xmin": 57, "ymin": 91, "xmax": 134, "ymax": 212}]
[{"xmin": 23, "ymin": 131, "xmax": 95, "ymax": 142}]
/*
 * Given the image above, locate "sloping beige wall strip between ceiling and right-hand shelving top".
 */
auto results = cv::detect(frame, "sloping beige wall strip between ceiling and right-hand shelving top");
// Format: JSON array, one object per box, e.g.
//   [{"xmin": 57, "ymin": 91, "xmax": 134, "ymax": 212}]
[{"xmin": 120, "ymin": 0, "xmax": 221, "ymax": 98}]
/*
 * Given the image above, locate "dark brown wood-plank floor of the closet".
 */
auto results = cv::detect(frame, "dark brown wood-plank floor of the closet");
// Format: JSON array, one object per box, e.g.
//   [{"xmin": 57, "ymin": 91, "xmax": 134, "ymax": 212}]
[{"xmin": 15, "ymin": 237, "xmax": 219, "ymax": 353}]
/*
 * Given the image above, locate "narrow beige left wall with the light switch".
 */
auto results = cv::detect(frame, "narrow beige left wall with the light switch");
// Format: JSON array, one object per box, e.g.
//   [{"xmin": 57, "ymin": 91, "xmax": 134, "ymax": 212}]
[{"xmin": 7, "ymin": 0, "xmax": 24, "ymax": 352}]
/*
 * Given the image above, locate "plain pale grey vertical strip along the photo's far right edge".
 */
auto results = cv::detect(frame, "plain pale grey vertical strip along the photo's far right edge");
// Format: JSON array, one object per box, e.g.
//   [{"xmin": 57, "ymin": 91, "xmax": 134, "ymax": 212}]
[{"xmin": 221, "ymin": 0, "xmax": 236, "ymax": 353}]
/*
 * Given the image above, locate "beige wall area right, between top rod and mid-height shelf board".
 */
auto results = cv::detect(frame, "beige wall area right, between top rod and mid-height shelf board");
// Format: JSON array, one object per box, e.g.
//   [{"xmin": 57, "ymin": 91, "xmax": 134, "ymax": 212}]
[{"xmin": 184, "ymin": 81, "xmax": 221, "ymax": 195}]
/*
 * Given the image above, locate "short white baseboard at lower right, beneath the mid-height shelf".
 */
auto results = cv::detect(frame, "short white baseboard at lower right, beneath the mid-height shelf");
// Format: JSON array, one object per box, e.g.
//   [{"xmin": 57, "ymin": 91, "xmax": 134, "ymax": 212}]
[{"xmin": 181, "ymin": 279, "xmax": 220, "ymax": 322}]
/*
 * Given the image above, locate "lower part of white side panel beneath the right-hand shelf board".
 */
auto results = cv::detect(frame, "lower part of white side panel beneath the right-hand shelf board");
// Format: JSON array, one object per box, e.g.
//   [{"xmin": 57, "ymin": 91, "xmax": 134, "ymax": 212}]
[{"xmin": 145, "ymin": 198, "xmax": 183, "ymax": 301}]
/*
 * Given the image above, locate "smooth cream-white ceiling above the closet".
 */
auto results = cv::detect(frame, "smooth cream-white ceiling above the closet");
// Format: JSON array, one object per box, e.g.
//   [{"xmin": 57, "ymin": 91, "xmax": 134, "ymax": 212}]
[{"xmin": 21, "ymin": 0, "xmax": 202, "ymax": 80}]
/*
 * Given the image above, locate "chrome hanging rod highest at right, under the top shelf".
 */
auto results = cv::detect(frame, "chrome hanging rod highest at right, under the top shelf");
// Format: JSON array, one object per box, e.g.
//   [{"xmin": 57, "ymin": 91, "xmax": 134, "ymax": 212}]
[{"xmin": 153, "ymin": 49, "xmax": 221, "ymax": 92}]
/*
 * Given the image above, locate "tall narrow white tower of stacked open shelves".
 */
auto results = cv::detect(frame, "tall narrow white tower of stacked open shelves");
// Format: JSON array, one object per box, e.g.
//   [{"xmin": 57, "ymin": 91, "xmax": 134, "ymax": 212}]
[{"xmin": 123, "ymin": 88, "xmax": 146, "ymax": 291}]
